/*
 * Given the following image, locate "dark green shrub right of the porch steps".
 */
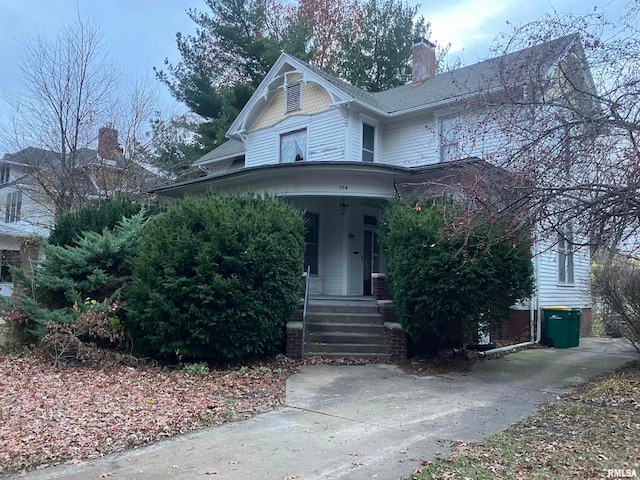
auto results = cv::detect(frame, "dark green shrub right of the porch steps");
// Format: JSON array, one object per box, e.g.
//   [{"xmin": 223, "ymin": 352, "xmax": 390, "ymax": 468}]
[{"xmin": 382, "ymin": 199, "xmax": 533, "ymax": 353}]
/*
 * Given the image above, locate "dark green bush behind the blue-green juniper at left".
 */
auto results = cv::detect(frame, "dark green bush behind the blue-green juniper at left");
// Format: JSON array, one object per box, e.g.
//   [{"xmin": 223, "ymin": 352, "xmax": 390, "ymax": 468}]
[{"xmin": 49, "ymin": 198, "xmax": 160, "ymax": 246}]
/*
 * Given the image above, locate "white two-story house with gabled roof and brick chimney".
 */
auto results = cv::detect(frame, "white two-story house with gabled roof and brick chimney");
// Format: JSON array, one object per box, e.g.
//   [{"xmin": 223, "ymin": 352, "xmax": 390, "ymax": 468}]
[{"xmin": 156, "ymin": 35, "xmax": 590, "ymax": 340}]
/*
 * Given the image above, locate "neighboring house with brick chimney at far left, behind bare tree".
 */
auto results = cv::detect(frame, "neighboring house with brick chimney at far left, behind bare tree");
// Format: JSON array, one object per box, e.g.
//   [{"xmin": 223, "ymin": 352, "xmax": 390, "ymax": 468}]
[{"xmin": 0, "ymin": 125, "xmax": 159, "ymax": 295}]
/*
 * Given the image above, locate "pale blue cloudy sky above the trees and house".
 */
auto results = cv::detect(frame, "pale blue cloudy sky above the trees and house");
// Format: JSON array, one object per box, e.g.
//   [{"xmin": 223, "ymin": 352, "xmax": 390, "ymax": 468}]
[{"xmin": 0, "ymin": 0, "xmax": 634, "ymax": 152}]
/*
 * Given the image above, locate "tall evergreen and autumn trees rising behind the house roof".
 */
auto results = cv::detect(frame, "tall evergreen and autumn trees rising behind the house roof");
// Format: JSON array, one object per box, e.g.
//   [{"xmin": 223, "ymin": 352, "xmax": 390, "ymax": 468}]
[{"xmin": 156, "ymin": 0, "xmax": 442, "ymax": 150}]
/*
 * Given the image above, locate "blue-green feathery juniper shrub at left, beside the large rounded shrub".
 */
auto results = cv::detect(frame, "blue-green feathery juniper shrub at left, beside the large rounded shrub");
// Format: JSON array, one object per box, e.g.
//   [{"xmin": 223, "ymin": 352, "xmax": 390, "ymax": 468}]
[{"xmin": 5, "ymin": 211, "xmax": 147, "ymax": 339}]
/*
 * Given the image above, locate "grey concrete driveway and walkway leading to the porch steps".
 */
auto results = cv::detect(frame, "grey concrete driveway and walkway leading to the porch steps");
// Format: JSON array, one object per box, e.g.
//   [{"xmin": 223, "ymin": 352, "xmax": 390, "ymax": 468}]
[{"xmin": 16, "ymin": 338, "xmax": 637, "ymax": 480}]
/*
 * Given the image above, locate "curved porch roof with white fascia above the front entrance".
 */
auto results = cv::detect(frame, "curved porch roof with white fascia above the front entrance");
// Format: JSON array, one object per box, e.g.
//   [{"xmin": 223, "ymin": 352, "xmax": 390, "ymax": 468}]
[{"xmin": 151, "ymin": 158, "xmax": 489, "ymax": 198}]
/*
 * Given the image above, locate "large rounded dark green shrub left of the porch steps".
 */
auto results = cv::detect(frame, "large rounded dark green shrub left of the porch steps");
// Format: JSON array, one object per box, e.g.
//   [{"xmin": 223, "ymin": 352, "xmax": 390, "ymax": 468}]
[{"xmin": 125, "ymin": 196, "xmax": 305, "ymax": 360}]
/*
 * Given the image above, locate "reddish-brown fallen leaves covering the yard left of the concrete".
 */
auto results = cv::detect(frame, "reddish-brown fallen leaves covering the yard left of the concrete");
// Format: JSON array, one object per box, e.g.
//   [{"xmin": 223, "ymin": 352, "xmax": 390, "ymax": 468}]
[{"xmin": 0, "ymin": 356, "xmax": 294, "ymax": 474}]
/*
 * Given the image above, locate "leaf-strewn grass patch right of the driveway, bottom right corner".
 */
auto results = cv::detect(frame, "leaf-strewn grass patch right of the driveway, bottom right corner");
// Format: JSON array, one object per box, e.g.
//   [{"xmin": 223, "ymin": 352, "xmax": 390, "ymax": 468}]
[{"xmin": 411, "ymin": 361, "xmax": 640, "ymax": 480}]
